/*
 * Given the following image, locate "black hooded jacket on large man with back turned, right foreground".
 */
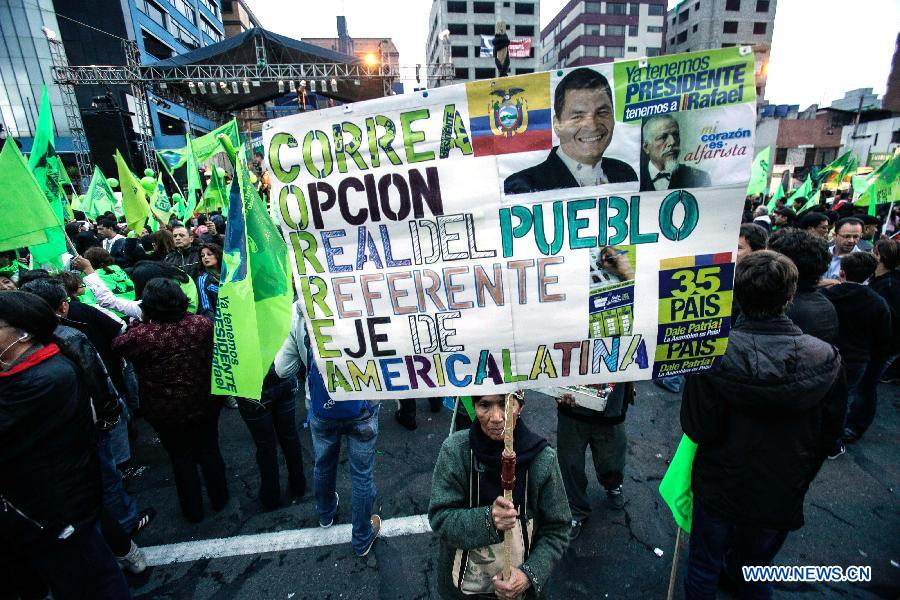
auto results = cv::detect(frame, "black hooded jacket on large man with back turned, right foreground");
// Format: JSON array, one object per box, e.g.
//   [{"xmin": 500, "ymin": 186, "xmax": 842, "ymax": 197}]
[{"xmin": 681, "ymin": 317, "xmax": 847, "ymax": 530}]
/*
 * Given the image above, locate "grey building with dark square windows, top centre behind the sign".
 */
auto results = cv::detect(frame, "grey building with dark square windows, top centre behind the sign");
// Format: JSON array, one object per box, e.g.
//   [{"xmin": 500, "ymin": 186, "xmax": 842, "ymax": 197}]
[{"xmin": 425, "ymin": 0, "xmax": 541, "ymax": 86}]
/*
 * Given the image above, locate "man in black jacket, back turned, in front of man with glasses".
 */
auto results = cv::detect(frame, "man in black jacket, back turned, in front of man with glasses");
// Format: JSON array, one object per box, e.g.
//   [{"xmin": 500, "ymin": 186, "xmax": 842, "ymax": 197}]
[{"xmin": 822, "ymin": 252, "xmax": 891, "ymax": 458}]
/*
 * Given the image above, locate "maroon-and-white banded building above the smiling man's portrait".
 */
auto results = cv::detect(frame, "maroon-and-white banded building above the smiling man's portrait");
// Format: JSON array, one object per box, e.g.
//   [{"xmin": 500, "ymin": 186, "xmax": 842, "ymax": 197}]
[{"xmin": 538, "ymin": 0, "xmax": 666, "ymax": 71}]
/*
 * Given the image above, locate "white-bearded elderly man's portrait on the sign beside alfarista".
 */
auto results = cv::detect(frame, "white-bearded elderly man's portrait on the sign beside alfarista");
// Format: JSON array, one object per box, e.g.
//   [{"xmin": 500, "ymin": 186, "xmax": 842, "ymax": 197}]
[{"xmin": 641, "ymin": 115, "xmax": 710, "ymax": 192}]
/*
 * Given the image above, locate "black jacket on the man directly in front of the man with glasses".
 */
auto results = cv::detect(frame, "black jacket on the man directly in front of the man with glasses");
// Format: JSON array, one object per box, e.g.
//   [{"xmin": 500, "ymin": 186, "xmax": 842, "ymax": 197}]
[{"xmin": 822, "ymin": 282, "xmax": 891, "ymax": 363}]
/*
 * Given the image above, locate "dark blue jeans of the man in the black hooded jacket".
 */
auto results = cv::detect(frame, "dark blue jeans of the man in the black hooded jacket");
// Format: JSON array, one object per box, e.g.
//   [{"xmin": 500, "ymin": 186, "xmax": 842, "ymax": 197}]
[{"xmin": 684, "ymin": 500, "xmax": 788, "ymax": 600}]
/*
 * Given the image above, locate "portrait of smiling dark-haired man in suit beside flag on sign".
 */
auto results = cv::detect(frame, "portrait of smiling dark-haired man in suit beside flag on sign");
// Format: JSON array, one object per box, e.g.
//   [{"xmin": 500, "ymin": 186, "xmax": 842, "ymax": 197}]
[{"xmin": 503, "ymin": 68, "xmax": 637, "ymax": 194}]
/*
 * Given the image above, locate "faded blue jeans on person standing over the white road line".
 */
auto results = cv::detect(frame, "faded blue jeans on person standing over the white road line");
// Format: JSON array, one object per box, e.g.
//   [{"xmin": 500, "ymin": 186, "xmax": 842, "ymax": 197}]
[{"xmin": 309, "ymin": 404, "xmax": 381, "ymax": 554}]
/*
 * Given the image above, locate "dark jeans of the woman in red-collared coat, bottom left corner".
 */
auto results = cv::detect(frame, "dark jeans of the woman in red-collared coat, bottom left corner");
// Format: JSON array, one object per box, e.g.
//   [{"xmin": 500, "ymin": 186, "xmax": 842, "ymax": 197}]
[{"xmin": 28, "ymin": 521, "xmax": 131, "ymax": 600}]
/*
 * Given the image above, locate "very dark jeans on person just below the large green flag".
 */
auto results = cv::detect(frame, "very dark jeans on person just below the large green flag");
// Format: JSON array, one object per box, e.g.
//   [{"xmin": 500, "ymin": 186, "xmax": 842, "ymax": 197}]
[{"xmin": 238, "ymin": 386, "xmax": 306, "ymax": 508}]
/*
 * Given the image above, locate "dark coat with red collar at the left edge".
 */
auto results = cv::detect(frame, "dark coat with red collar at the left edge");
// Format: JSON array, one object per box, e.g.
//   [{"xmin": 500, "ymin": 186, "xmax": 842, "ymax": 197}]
[{"xmin": 0, "ymin": 344, "xmax": 102, "ymax": 548}]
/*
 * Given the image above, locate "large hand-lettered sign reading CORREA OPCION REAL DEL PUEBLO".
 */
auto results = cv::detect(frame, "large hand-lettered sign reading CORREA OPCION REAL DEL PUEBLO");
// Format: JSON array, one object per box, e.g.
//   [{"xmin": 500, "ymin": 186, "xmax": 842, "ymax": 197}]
[{"xmin": 263, "ymin": 48, "xmax": 756, "ymax": 399}]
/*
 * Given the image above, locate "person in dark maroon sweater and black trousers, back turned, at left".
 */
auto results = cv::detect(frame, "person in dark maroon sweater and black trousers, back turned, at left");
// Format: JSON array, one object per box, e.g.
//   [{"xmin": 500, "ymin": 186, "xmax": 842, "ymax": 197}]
[{"xmin": 113, "ymin": 278, "xmax": 228, "ymax": 523}]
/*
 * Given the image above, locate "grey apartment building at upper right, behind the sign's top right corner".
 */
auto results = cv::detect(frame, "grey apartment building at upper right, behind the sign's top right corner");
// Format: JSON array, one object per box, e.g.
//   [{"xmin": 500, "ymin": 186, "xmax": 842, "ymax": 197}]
[{"xmin": 665, "ymin": 0, "xmax": 777, "ymax": 102}]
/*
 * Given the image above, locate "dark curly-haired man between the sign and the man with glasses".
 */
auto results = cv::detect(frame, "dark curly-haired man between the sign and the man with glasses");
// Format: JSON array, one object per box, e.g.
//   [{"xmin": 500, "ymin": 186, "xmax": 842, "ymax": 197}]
[{"xmin": 768, "ymin": 229, "xmax": 840, "ymax": 344}]
